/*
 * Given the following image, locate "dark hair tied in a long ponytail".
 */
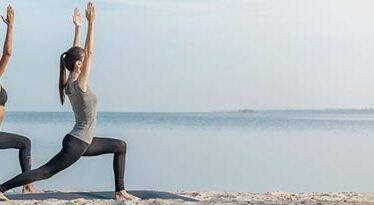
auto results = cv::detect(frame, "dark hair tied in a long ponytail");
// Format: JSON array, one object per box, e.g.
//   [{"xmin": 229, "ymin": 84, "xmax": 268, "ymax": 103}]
[{"xmin": 58, "ymin": 46, "xmax": 84, "ymax": 105}]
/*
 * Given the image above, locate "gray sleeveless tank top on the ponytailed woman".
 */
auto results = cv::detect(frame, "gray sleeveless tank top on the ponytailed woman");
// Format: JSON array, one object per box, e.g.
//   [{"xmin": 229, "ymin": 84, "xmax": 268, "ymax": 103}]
[{"xmin": 65, "ymin": 80, "xmax": 97, "ymax": 144}]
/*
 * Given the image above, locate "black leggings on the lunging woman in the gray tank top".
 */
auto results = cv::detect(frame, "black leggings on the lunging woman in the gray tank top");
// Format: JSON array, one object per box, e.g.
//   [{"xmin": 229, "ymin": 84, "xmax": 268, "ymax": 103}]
[{"xmin": 0, "ymin": 135, "xmax": 126, "ymax": 193}]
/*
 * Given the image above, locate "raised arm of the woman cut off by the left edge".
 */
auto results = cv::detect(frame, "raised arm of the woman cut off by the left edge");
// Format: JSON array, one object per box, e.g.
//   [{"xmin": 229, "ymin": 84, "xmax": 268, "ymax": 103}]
[{"xmin": 0, "ymin": 5, "xmax": 14, "ymax": 76}]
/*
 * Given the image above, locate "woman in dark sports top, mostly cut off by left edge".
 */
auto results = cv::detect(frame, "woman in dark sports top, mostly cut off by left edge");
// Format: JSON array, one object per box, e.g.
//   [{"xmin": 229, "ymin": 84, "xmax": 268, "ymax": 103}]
[{"xmin": 0, "ymin": 5, "xmax": 37, "ymax": 193}]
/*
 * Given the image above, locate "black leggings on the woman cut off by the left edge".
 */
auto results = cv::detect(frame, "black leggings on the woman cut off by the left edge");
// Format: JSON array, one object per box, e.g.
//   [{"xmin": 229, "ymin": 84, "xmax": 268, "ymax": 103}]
[{"xmin": 0, "ymin": 132, "xmax": 31, "ymax": 172}]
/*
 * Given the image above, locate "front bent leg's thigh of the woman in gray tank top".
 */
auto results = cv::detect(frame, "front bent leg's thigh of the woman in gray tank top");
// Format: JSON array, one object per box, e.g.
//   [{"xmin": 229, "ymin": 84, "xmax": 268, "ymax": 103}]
[{"xmin": 83, "ymin": 137, "xmax": 124, "ymax": 156}]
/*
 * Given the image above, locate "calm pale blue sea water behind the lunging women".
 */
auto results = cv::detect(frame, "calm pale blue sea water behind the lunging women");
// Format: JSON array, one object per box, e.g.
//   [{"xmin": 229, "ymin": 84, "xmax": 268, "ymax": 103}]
[{"xmin": 0, "ymin": 110, "xmax": 374, "ymax": 192}]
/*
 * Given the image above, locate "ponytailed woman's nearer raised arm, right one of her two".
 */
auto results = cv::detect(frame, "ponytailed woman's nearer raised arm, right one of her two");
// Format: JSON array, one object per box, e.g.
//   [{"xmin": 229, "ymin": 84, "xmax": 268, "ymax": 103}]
[{"xmin": 78, "ymin": 2, "xmax": 95, "ymax": 92}]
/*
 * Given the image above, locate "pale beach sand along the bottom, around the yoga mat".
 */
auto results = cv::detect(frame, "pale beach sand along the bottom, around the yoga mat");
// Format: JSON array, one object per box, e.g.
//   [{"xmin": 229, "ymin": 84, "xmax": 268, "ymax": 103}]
[{"xmin": 0, "ymin": 192, "xmax": 374, "ymax": 205}]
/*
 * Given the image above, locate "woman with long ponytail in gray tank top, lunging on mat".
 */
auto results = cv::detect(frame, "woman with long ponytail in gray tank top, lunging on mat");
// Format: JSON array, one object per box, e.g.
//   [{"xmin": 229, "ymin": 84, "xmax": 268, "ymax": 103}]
[{"xmin": 0, "ymin": 3, "xmax": 138, "ymax": 200}]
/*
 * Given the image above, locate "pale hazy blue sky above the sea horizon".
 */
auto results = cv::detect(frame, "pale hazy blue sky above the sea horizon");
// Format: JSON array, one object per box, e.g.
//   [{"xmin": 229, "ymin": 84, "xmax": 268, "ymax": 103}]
[{"xmin": 0, "ymin": 0, "xmax": 374, "ymax": 112}]
